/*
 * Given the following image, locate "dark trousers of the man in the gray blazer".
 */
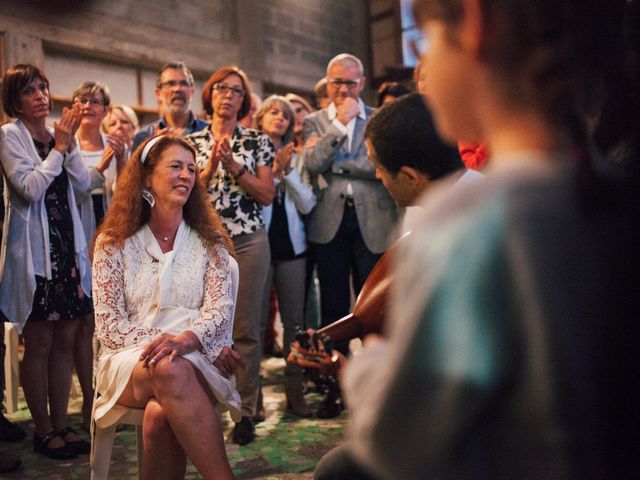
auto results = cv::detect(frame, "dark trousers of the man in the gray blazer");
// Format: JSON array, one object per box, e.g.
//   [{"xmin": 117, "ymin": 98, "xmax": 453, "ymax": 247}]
[{"xmin": 316, "ymin": 201, "xmax": 382, "ymax": 353}]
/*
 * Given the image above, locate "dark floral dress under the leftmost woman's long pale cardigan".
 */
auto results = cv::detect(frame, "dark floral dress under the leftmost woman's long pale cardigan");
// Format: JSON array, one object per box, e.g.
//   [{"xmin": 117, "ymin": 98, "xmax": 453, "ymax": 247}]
[{"xmin": 27, "ymin": 139, "xmax": 92, "ymax": 322}]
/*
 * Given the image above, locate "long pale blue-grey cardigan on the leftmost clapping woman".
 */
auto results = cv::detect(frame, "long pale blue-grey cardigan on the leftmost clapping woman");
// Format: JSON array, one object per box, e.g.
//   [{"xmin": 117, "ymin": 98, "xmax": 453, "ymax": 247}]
[{"xmin": 0, "ymin": 120, "xmax": 91, "ymax": 331}]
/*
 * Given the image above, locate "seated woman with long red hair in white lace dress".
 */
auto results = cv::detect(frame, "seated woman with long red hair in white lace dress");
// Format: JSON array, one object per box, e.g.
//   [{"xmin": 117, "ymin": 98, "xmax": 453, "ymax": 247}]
[{"xmin": 93, "ymin": 135, "xmax": 240, "ymax": 479}]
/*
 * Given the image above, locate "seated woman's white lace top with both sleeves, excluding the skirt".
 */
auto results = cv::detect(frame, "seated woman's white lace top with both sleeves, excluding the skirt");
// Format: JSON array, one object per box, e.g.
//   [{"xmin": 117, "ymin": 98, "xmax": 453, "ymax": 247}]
[{"xmin": 93, "ymin": 223, "xmax": 233, "ymax": 363}]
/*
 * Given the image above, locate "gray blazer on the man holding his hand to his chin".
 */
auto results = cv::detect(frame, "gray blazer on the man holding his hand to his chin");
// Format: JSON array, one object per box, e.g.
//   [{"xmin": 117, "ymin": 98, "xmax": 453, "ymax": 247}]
[{"xmin": 302, "ymin": 107, "xmax": 403, "ymax": 253}]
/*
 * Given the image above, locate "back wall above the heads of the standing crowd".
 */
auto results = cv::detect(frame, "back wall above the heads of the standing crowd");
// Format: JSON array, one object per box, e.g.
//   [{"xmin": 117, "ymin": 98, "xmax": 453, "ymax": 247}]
[{"xmin": 0, "ymin": 0, "xmax": 369, "ymax": 112}]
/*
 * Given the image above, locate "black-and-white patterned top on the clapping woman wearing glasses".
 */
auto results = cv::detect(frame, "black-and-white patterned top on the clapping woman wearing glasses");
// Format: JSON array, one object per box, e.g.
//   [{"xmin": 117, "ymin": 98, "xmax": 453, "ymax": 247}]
[{"xmin": 186, "ymin": 125, "xmax": 275, "ymax": 237}]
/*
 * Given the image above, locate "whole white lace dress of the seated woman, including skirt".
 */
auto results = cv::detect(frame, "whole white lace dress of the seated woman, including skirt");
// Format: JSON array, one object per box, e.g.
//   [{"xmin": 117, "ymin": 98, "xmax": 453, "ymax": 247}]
[{"xmin": 93, "ymin": 222, "xmax": 241, "ymax": 427}]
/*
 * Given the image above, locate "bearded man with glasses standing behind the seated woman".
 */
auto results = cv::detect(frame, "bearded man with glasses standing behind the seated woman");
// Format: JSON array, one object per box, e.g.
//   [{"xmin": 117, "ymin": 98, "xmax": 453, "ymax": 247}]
[{"xmin": 132, "ymin": 62, "xmax": 207, "ymax": 151}]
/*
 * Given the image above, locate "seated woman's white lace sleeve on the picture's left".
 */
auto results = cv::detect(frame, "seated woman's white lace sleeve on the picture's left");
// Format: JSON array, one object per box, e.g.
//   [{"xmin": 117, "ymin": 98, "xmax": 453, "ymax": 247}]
[{"xmin": 93, "ymin": 238, "xmax": 162, "ymax": 350}]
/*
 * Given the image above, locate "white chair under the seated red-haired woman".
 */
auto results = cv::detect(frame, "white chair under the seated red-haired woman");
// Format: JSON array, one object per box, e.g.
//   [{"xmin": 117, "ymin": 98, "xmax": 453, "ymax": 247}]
[{"xmin": 90, "ymin": 257, "xmax": 240, "ymax": 480}]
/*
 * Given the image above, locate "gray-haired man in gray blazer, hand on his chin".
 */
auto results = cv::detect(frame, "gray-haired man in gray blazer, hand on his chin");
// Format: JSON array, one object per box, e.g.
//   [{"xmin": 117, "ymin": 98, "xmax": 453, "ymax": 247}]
[{"xmin": 302, "ymin": 53, "xmax": 402, "ymax": 418}]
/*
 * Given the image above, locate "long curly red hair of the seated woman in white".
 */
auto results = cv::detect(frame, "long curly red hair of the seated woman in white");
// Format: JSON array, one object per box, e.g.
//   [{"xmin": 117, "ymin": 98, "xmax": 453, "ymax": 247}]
[{"xmin": 91, "ymin": 135, "xmax": 233, "ymax": 254}]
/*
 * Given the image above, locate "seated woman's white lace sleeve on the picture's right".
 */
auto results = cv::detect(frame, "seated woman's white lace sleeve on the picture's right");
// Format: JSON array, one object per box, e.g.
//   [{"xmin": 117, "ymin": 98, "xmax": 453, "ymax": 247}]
[{"xmin": 191, "ymin": 245, "xmax": 233, "ymax": 363}]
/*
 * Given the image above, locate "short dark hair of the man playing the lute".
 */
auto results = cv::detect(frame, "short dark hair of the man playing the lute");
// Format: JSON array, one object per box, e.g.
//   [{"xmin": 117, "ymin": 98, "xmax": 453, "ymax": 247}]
[{"xmin": 364, "ymin": 93, "xmax": 464, "ymax": 180}]
